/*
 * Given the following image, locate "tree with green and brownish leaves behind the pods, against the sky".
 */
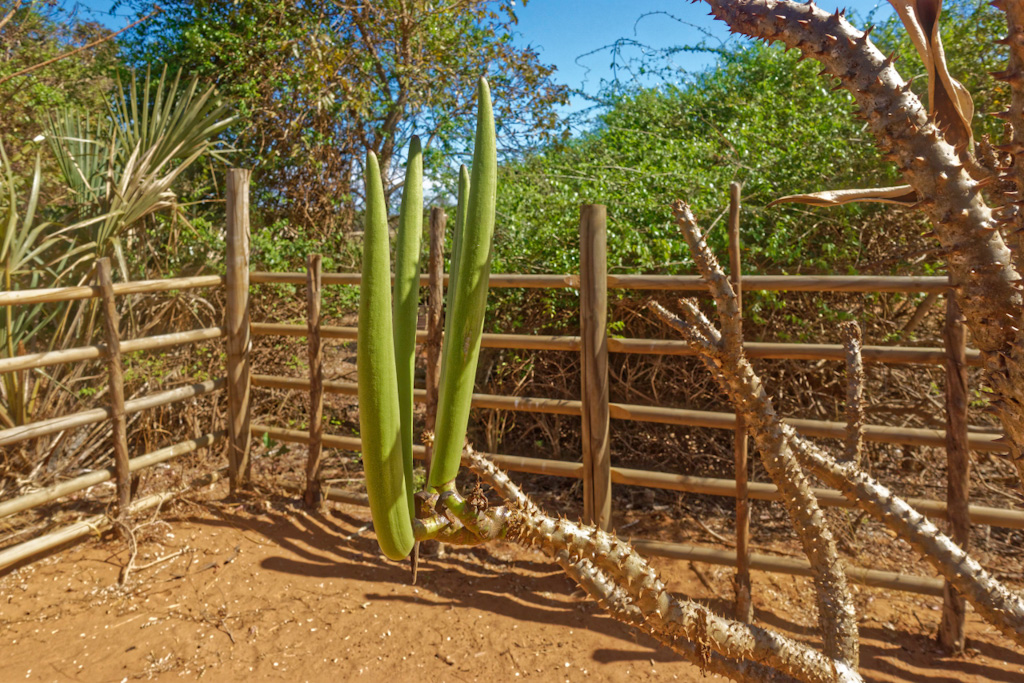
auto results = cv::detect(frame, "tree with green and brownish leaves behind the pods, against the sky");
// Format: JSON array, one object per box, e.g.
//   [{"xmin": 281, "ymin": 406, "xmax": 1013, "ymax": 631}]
[{"xmin": 119, "ymin": 0, "xmax": 565, "ymax": 234}]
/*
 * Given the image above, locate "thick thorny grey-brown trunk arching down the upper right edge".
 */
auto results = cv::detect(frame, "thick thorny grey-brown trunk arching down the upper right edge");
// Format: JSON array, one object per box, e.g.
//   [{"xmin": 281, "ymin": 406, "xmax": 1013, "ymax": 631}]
[{"xmin": 706, "ymin": 0, "xmax": 1024, "ymax": 479}]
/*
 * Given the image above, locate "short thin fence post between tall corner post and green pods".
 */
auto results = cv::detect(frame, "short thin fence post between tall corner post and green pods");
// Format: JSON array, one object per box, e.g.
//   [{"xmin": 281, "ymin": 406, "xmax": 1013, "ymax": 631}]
[{"xmin": 303, "ymin": 254, "xmax": 324, "ymax": 508}]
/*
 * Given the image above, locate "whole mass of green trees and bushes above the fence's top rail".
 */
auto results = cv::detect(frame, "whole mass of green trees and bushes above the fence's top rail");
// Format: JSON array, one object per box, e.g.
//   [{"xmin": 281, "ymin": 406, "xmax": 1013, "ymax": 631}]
[{"xmin": 0, "ymin": 0, "xmax": 1007, "ymax": 335}]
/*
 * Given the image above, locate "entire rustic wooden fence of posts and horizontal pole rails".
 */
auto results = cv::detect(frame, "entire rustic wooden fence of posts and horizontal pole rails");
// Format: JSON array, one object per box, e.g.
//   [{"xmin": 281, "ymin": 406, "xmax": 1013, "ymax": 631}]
[{"xmin": 0, "ymin": 170, "xmax": 1024, "ymax": 647}]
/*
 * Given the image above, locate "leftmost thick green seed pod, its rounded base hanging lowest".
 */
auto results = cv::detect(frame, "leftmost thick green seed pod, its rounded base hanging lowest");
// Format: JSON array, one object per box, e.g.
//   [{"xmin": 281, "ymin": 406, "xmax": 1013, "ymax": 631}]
[{"xmin": 356, "ymin": 152, "xmax": 415, "ymax": 560}]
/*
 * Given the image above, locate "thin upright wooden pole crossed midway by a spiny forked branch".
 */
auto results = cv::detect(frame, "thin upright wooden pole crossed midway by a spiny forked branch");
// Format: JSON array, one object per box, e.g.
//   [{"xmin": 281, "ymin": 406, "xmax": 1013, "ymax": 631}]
[{"xmin": 729, "ymin": 182, "xmax": 754, "ymax": 624}]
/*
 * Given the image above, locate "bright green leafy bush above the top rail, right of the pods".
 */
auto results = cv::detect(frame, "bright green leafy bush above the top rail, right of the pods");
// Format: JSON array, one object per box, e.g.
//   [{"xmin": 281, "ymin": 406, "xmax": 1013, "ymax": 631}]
[{"xmin": 496, "ymin": 2, "xmax": 1005, "ymax": 282}]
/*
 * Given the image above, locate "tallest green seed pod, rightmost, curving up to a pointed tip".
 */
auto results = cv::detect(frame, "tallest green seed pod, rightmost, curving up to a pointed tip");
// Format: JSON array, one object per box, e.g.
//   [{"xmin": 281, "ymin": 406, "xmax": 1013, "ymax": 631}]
[{"xmin": 429, "ymin": 78, "xmax": 498, "ymax": 489}]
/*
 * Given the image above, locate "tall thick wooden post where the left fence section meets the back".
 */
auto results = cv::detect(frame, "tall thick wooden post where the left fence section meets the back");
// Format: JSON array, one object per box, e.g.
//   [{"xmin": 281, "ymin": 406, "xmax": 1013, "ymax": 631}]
[{"xmin": 224, "ymin": 168, "xmax": 252, "ymax": 494}]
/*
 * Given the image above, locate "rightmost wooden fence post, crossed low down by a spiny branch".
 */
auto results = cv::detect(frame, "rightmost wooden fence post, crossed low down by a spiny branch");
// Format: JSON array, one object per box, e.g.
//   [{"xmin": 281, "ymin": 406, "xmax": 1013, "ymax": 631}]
[{"xmin": 939, "ymin": 292, "xmax": 971, "ymax": 654}]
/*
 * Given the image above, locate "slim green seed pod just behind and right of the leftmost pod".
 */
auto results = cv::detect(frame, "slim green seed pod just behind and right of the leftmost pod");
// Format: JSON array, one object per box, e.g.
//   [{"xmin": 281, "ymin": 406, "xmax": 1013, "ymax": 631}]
[{"xmin": 392, "ymin": 135, "xmax": 423, "ymax": 495}]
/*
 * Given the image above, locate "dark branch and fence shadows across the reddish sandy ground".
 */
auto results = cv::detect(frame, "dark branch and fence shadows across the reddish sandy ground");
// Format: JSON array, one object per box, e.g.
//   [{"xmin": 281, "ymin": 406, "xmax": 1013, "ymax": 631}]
[{"xmin": 188, "ymin": 499, "xmax": 1024, "ymax": 683}]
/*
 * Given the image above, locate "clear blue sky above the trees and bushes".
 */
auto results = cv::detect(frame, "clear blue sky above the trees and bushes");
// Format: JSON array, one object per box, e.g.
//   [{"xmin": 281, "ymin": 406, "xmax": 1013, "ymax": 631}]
[{"xmin": 70, "ymin": 0, "xmax": 892, "ymax": 110}]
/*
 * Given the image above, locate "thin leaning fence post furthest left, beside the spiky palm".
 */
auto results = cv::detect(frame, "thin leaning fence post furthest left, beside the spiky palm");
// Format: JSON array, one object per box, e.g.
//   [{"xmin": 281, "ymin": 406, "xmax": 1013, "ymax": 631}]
[{"xmin": 96, "ymin": 258, "xmax": 131, "ymax": 514}]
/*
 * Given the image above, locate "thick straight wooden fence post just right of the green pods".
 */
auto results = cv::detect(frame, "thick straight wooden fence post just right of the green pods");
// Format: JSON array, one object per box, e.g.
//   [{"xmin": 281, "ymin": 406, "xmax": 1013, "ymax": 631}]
[{"xmin": 580, "ymin": 204, "xmax": 611, "ymax": 529}]
